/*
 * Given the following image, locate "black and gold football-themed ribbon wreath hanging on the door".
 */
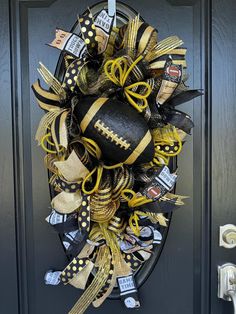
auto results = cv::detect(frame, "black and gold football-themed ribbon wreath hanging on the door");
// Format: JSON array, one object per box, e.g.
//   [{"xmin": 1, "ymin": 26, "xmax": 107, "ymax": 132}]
[{"xmin": 32, "ymin": 3, "xmax": 201, "ymax": 314}]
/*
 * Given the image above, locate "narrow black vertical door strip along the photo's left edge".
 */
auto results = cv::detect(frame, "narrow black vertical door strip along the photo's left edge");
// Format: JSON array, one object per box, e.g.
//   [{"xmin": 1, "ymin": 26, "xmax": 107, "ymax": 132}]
[{"xmin": 0, "ymin": 0, "xmax": 19, "ymax": 314}]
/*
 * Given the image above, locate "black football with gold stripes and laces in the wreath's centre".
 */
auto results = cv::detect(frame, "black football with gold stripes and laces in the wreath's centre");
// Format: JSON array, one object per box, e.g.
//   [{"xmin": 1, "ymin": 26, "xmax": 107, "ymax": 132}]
[{"xmin": 73, "ymin": 97, "xmax": 154, "ymax": 165}]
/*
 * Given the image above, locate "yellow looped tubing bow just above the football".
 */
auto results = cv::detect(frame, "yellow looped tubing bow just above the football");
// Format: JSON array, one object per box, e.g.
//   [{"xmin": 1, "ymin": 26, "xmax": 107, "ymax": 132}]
[{"xmin": 104, "ymin": 55, "xmax": 151, "ymax": 112}]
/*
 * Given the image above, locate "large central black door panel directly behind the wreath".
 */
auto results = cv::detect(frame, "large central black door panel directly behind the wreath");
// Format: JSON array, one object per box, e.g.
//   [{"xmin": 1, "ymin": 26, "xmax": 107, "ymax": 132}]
[{"xmin": 15, "ymin": 0, "xmax": 201, "ymax": 314}]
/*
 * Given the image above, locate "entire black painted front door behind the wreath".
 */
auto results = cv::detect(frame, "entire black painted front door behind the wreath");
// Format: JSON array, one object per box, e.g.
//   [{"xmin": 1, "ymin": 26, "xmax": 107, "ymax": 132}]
[{"xmin": 0, "ymin": 0, "xmax": 236, "ymax": 314}]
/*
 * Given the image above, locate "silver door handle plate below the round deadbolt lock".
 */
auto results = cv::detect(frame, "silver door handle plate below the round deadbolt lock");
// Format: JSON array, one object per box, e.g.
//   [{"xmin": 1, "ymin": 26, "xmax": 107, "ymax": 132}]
[{"xmin": 218, "ymin": 263, "xmax": 236, "ymax": 314}]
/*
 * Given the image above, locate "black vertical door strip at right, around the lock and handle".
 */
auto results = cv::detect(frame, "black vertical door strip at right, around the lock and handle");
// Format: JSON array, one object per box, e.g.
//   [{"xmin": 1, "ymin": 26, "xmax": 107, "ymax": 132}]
[{"xmin": 211, "ymin": 0, "xmax": 236, "ymax": 314}]
